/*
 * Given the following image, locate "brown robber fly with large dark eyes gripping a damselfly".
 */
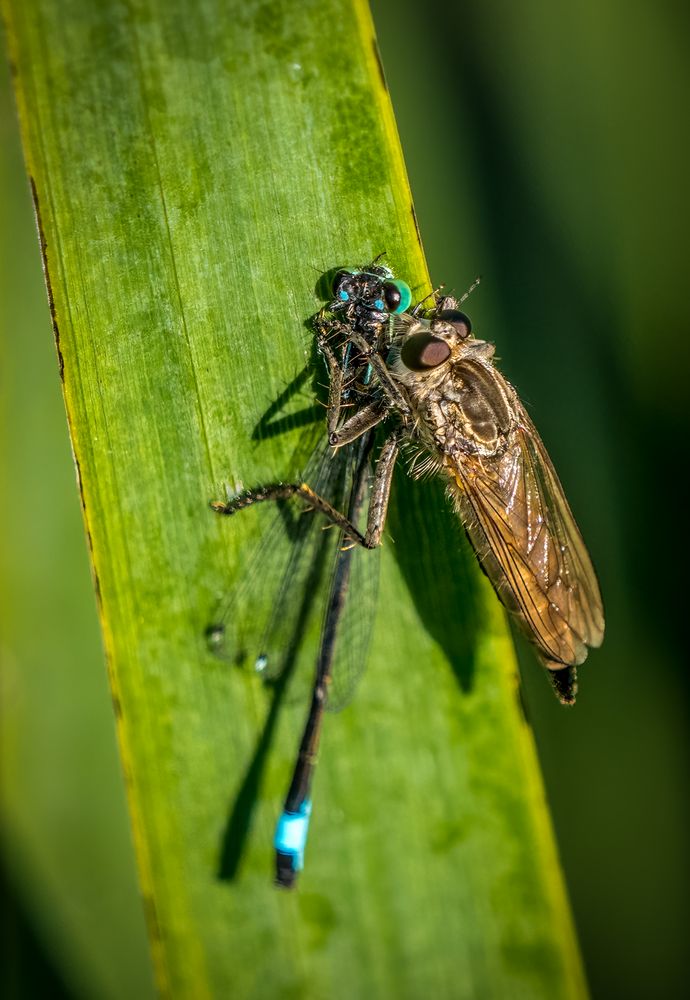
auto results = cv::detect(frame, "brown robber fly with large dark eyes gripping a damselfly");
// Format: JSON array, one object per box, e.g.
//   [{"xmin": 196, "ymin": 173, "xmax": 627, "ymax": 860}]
[{"xmin": 324, "ymin": 296, "xmax": 604, "ymax": 704}]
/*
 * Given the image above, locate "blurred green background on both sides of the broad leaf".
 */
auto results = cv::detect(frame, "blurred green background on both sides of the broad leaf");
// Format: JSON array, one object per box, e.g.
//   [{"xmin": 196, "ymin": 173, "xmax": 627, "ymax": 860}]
[{"xmin": 0, "ymin": 0, "xmax": 690, "ymax": 998}]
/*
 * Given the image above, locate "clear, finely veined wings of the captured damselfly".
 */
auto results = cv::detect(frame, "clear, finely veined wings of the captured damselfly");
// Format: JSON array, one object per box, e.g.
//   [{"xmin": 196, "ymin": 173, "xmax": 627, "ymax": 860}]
[{"xmin": 207, "ymin": 435, "xmax": 378, "ymax": 708}]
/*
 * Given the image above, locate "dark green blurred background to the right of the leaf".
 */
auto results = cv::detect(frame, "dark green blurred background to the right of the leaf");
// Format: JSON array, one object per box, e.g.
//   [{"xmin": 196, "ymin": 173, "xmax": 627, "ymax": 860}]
[{"xmin": 373, "ymin": 0, "xmax": 690, "ymax": 998}]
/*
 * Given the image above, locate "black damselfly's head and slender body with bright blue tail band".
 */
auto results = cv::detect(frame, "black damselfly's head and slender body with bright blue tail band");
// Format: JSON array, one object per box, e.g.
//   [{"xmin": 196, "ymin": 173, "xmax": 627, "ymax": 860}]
[{"xmin": 212, "ymin": 258, "xmax": 412, "ymax": 888}]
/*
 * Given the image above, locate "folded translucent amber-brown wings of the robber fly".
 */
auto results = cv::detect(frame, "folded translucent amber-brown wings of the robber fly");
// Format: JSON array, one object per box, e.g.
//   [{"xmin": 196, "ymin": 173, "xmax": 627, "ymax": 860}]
[{"xmin": 445, "ymin": 399, "xmax": 604, "ymax": 668}]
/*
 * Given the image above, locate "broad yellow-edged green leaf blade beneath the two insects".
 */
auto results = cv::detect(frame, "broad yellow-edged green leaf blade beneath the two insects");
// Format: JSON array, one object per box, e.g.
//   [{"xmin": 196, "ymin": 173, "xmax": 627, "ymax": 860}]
[{"xmin": 5, "ymin": 0, "xmax": 585, "ymax": 998}]
